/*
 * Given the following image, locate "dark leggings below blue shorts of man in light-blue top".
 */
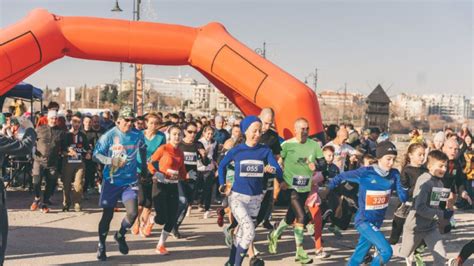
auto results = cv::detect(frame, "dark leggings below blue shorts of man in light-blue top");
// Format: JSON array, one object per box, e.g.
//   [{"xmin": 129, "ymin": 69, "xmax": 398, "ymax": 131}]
[{"xmin": 99, "ymin": 200, "xmax": 138, "ymax": 245}]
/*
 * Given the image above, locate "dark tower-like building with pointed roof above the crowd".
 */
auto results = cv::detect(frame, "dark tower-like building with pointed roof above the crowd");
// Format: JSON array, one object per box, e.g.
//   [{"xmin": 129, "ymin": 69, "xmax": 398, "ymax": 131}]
[{"xmin": 365, "ymin": 84, "xmax": 390, "ymax": 130}]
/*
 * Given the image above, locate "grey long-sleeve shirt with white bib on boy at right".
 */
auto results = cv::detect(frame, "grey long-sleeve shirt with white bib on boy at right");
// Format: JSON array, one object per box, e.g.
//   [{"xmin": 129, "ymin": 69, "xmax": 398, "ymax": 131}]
[{"xmin": 404, "ymin": 173, "xmax": 451, "ymax": 232}]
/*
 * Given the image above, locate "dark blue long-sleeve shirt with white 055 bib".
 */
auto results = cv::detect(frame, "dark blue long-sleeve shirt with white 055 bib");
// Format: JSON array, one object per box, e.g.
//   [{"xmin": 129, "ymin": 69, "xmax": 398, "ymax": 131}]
[{"xmin": 218, "ymin": 143, "xmax": 283, "ymax": 196}]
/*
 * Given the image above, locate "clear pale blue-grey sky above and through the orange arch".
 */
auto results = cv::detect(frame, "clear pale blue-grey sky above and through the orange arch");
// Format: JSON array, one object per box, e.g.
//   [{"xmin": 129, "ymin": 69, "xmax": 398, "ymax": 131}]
[{"xmin": 0, "ymin": 0, "xmax": 474, "ymax": 97}]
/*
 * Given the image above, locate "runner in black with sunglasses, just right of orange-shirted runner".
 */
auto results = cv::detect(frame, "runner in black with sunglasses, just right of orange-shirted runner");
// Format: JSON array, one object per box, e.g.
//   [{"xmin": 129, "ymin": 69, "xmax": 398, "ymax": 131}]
[{"xmin": 171, "ymin": 122, "xmax": 206, "ymax": 239}]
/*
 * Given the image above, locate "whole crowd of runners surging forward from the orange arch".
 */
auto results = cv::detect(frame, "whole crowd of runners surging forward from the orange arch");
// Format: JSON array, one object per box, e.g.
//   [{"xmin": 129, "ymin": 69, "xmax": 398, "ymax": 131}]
[{"xmin": 0, "ymin": 102, "xmax": 474, "ymax": 266}]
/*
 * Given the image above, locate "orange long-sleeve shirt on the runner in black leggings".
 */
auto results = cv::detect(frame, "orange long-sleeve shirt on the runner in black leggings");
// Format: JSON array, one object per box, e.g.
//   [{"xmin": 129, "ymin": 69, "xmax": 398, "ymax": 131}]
[{"xmin": 148, "ymin": 143, "xmax": 187, "ymax": 183}]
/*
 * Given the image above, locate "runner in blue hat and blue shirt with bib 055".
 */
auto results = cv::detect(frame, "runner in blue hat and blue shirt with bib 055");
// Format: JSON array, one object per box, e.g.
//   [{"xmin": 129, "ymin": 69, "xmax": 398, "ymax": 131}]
[{"xmin": 219, "ymin": 116, "xmax": 282, "ymax": 266}]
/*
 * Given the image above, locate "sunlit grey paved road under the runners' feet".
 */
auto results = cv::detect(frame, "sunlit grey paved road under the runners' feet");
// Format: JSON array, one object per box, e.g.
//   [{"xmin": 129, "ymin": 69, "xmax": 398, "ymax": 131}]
[{"xmin": 5, "ymin": 191, "xmax": 474, "ymax": 266}]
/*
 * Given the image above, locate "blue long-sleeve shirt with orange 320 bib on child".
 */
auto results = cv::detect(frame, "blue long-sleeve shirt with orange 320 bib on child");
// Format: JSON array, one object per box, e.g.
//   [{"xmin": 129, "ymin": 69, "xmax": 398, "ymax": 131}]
[{"xmin": 329, "ymin": 166, "xmax": 408, "ymax": 227}]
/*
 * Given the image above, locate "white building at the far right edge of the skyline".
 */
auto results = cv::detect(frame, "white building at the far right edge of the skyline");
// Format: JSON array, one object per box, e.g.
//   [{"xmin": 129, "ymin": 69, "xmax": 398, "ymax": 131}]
[{"xmin": 423, "ymin": 94, "xmax": 472, "ymax": 120}]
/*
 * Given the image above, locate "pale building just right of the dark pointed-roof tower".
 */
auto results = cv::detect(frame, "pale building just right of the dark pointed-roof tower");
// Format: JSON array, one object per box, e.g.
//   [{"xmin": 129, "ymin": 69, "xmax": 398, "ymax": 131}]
[{"xmin": 392, "ymin": 93, "xmax": 428, "ymax": 120}]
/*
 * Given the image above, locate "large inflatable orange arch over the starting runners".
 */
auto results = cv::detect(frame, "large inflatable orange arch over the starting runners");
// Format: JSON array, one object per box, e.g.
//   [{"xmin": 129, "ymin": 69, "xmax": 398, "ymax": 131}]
[{"xmin": 0, "ymin": 9, "xmax": 323, "ymax": 139}]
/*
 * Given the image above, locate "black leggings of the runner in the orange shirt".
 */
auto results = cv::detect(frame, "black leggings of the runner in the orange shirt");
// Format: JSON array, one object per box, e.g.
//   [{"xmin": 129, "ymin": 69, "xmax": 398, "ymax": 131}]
[{"xmin": 153, "ymin": 183, "xmax": 179, "ymax": 232}]
